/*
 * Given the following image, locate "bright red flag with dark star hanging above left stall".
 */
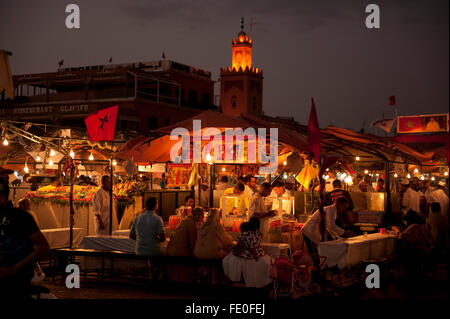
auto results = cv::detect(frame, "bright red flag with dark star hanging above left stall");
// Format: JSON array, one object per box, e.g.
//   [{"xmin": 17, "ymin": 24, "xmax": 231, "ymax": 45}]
[{"xmin": 84, "ymin": 105, "xmax": 119, "ymax": 142}]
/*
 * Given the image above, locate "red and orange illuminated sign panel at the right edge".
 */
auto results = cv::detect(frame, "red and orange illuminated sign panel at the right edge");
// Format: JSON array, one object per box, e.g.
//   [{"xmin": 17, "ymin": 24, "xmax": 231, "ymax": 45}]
[{"xmin": 397, "ymin": 113, "xmax": 448, "ymax": 133}]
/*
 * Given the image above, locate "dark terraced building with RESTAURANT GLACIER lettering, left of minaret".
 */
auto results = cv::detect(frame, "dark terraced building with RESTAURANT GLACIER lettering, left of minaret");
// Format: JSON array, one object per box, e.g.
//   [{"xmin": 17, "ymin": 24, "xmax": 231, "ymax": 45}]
[{"xmin": 0, "ymin": 60, "xmax": 217, "ymax": 130}]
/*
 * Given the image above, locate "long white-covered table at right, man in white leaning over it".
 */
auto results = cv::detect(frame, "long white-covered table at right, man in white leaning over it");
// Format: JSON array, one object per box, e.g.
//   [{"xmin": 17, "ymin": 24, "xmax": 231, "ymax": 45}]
[{"xmin": 319, "ymin": 233, "xmax": 397, "ymax": 269}]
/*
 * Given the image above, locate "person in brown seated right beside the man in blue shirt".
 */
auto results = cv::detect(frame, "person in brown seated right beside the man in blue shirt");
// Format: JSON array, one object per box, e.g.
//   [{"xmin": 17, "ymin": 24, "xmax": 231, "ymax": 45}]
[{"xmin": 166, "ymin": 207, "xmax": 203, "ymax": 282}]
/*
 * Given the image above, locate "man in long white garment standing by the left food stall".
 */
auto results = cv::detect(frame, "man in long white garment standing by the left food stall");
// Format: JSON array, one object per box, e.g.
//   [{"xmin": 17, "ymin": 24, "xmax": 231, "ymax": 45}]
[{"xmin": 92, "ymin": 175, "xmax": 111, "ymax": 235}]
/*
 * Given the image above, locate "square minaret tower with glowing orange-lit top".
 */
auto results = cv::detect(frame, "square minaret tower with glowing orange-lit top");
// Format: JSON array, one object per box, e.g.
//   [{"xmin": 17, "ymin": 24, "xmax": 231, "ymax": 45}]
[{"xmin": 220, "ymin": 18, "xmax": 263, "ymax": 116}]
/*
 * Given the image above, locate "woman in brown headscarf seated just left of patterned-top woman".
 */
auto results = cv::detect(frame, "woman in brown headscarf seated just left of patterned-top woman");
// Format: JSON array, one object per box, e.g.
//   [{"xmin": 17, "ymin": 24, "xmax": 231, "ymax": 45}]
[{"xmin": 194, "ymin": 208, "xmax": 233, "ymax": 259}]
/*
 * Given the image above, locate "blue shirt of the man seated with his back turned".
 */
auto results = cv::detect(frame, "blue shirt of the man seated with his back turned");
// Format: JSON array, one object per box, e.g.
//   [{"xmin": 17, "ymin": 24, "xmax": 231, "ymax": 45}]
[{"xmin": 130, "ymin": 210, "xmax": 164, "ymax": 256}]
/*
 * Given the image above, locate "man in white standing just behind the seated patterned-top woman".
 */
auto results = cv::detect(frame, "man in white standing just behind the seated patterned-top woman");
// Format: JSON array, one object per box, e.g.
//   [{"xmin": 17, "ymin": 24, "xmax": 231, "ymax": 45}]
[{"xmin": 248, "ymin": 183, "xmax": 276, "ymax": 242}]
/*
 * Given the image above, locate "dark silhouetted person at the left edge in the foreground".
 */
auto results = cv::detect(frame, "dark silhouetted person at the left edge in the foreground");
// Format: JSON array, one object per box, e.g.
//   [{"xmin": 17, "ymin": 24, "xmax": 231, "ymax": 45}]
[{"xmin": 0, "ymin": 178, "xmax": 49, "ymax": 301}]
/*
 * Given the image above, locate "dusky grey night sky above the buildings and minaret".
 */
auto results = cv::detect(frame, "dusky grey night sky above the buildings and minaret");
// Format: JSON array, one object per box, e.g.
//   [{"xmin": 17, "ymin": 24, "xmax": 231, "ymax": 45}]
[{"xmin": 0, "ymin": 0, "xmax": 449, "ymax": 133}]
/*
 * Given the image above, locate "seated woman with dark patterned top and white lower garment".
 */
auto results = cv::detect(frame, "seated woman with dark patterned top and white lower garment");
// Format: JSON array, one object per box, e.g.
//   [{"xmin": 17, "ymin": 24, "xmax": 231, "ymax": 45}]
[{"xmin": 223, "ymin": 217, "xmax": 272, "ymax": 288}]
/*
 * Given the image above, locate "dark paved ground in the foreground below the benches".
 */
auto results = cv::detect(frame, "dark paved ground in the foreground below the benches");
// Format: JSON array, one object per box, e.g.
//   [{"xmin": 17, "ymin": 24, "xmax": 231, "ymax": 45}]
[{"xmin": 40, "ymin": 265, "xmax": 449, "ymax": 300}]
